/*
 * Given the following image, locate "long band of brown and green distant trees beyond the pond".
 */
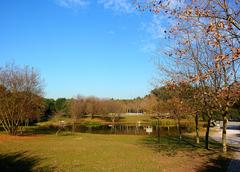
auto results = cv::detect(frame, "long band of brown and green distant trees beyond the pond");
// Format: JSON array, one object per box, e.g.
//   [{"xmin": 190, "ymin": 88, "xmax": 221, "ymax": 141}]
[{"xmin": 40, "ymin": 87, "xmax": 240, "ymax": 121}]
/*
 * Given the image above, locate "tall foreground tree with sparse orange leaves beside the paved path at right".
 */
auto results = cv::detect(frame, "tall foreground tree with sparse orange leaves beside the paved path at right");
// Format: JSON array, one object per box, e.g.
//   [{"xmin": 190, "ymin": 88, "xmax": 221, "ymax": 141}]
[{"xmin": 137, "ymin": 0, "xmax": 240, "ymax": 152}]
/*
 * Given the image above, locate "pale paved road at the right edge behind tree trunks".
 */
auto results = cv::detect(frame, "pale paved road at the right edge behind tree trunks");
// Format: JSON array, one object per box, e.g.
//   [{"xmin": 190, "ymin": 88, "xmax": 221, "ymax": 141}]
[{"xmin": 211, "ymin": 122, "xmax": 240, "ymax": 172}]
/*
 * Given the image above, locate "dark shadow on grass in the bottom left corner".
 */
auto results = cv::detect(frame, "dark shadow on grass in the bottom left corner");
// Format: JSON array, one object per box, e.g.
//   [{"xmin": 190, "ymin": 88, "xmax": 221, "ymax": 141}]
[{"xmin": 0, "ymin": 152, "xmax": 54, "ymax": 172}]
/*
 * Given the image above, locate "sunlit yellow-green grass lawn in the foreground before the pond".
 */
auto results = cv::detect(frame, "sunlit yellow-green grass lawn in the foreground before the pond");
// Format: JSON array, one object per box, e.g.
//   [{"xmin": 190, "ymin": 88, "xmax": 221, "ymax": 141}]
[{"xmin": 0, "ymin": 133, "xmax": 231, "ymax": 172}]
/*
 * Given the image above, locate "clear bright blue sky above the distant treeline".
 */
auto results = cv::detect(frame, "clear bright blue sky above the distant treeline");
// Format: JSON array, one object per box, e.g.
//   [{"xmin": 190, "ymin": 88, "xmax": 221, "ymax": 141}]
[{"xmin": 0, "ymin": 0, "xmax": 169, "ymax": 99}]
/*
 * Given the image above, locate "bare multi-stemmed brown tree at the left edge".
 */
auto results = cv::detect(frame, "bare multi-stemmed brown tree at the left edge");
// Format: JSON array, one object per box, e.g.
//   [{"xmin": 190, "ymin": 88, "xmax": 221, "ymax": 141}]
[{"xmin": 0, "ymin": 64, "xmax": 43, "ymax": 135}]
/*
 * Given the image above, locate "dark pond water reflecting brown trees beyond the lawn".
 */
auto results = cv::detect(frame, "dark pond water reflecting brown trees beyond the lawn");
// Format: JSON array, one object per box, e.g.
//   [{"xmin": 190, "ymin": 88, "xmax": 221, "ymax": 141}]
[{"xmin": 63, "ymin": 125, "xmax": 192, "ymax": 135}]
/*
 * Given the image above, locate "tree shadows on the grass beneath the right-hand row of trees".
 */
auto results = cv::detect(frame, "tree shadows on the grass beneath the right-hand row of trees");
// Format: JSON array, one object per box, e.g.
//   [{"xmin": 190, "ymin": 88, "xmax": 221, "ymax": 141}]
[{"xmin": 141, "ymin": 136, "xmax": 234, "ymax": 172}]
